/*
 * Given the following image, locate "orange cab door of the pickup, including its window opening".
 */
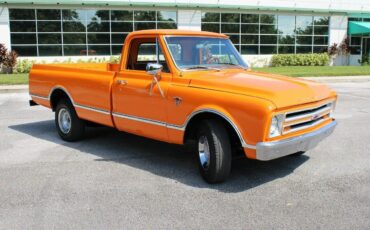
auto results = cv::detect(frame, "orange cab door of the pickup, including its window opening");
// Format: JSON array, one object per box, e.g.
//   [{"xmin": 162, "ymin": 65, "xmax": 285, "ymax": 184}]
[{"xmin": 112, "ymin": 37, "xmax": 172, "ymax": 141}]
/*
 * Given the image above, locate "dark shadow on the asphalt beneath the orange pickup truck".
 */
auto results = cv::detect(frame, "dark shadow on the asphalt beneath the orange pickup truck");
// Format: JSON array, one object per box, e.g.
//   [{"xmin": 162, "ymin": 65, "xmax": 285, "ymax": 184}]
[{"xmin": 9, "ymin": 120, "xmax": 308, "ymax": 193}]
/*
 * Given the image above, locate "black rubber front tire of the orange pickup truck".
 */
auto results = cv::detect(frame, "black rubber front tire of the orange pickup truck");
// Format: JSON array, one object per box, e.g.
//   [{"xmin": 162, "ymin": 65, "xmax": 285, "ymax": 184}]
[{"xmin": 197, "ymin": 120, "xmax": 232, "ymax": 183}]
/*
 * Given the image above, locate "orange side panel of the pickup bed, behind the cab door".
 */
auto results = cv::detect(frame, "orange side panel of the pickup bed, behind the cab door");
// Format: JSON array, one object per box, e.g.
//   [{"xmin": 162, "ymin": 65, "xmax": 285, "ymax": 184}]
[{"xmin": 30, "ymin": 64, "xmax": 115, "ymax": 127}]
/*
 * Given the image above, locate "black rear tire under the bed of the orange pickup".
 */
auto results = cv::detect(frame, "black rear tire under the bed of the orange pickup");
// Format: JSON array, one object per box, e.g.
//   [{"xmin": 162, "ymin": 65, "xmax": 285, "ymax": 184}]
[{"xmin": 55, "ymin": 99, "xmax": 85, "ymax": 142}]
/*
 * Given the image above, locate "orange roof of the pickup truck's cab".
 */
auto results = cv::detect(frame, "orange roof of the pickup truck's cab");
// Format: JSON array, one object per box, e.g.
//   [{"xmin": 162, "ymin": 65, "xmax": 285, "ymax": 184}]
[{"xmin": 129, "ymin": 29, "xmax": 228, "ymax": 38}]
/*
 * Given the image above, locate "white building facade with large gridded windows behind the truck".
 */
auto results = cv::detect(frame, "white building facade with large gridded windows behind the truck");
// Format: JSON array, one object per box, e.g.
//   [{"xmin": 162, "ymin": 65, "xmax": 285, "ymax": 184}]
[{"xmin": 0, "ymin": 0, "xmax": 370, "ymax": 66}]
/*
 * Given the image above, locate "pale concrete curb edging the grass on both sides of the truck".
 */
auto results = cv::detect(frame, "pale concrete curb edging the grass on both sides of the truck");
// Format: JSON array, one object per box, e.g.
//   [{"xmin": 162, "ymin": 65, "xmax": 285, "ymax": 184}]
[{"xmin": 0, "ymin": 76, "xmax": 370, "ymax": 93}]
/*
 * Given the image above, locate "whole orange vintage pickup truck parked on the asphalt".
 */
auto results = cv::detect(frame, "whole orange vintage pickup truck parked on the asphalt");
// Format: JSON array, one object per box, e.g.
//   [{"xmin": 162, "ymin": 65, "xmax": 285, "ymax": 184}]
[{"xmin": 29, "ymin": 30, "xmax": 337, "ymax": 183}]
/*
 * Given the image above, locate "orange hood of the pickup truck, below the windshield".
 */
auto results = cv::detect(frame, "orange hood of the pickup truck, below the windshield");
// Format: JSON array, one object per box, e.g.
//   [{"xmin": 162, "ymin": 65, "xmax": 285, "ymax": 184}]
[{"xmin": 189, "ymin": 70, "xmax": 333, "ymax": 108}]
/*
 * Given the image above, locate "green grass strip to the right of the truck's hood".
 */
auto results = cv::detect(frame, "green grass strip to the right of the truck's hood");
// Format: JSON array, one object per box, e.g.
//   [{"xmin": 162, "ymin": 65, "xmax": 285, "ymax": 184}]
[{"xmin": 252, "ymin": 66, "xmax": 370, "ymax": 77}]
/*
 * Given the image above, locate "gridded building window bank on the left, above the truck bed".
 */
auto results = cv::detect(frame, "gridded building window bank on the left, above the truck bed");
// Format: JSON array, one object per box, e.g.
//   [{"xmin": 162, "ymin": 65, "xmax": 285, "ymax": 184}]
[{"xmin": 9, "ymin": 9, "xmax": 177, "ymax": 56}]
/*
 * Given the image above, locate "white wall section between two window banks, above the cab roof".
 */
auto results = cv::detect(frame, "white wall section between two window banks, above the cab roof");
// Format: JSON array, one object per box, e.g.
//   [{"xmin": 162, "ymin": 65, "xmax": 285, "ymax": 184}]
[{"xmin": 177, "ymin": 10, "xmax": 202, "ymax": 31}]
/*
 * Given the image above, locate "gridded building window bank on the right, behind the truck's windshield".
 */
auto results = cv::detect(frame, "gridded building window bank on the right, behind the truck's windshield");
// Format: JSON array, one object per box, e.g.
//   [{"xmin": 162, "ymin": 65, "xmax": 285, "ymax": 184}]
[{"xmin": 201, "ymin": 12, "xmax": 329, "ymax": 54}]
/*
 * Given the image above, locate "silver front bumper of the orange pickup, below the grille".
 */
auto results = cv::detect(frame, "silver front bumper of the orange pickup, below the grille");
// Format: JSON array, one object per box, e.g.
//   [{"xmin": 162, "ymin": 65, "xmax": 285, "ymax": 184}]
[{"xmin": 256, "ymin": 120, "xmax": 337, "ymax": 161}]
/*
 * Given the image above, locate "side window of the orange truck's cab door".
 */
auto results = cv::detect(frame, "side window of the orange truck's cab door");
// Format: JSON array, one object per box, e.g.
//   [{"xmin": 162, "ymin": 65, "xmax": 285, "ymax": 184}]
[{"xmin": 127, "ymin": 39, "xmax": 170, "ymax": 73}]
